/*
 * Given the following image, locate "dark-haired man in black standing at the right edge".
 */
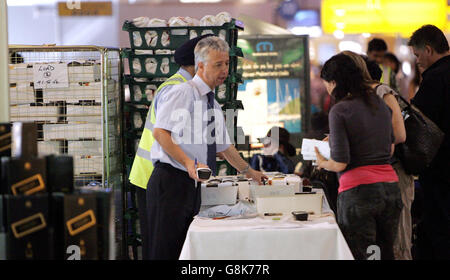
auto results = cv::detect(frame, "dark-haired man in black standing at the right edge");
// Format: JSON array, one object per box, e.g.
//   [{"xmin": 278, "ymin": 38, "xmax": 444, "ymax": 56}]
[{"xmin": 408, "ymin": 25, "xmax": 450, "ymax": 260}]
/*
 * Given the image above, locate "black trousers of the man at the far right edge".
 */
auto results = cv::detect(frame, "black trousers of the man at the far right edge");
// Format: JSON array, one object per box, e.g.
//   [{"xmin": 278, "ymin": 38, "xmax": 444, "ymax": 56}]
[{"xmin": 417, "ymin": 170, "xmax": 450, "ymax": 260}]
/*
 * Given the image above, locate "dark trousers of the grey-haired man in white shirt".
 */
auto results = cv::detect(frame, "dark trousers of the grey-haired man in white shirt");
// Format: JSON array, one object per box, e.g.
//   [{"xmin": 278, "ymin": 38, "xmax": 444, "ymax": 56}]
[{"xmin": 147, "ymin": 162, "xmax": 201, "ymax": 260}]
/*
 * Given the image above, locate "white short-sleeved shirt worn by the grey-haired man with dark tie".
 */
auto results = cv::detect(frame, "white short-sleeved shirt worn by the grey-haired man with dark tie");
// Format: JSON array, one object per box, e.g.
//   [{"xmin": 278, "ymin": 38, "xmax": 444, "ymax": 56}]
[{"xmin": 151, "ymin": 75, "xmax": 231, "ymax": 171}]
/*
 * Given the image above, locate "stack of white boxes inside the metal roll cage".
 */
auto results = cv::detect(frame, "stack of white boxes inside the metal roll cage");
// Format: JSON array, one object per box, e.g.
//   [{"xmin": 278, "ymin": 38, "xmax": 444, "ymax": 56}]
[{"xmin": 9, "ymin": 56, "xmax": 118, "ymax": 184}]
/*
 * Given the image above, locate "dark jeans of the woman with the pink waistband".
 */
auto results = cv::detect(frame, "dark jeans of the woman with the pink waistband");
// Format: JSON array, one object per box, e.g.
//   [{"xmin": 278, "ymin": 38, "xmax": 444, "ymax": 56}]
[{"xmin": 337, "ymin": 182, "xmax": 403, "ymax": 260}]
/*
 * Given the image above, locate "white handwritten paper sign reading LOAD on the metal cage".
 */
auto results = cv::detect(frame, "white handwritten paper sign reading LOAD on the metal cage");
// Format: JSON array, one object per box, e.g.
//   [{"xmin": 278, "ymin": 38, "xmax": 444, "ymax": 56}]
[{"xmin": 33, "ymin": 63, "xmax": 69, "ymax": 89}]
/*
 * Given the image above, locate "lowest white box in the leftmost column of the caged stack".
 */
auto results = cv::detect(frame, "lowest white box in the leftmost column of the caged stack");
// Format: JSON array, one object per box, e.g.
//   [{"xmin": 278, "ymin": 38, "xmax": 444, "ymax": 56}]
[{"xmin": 10, "ymin": 104, "xmax": 60, "ymax": 123}]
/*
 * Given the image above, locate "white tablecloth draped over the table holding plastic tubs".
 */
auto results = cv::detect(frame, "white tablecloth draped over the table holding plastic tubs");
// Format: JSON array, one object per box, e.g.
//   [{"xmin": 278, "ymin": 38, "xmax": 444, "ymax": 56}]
[{"xmin": 180, "ymin": 200, "xmax": 353, "ymax": 260}]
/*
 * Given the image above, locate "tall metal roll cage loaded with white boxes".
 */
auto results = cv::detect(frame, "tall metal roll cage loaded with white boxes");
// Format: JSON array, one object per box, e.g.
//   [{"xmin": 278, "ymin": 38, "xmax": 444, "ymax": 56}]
[{"xmin": 9, "ymin": 45, "xmax": 124, "ymax": 258}]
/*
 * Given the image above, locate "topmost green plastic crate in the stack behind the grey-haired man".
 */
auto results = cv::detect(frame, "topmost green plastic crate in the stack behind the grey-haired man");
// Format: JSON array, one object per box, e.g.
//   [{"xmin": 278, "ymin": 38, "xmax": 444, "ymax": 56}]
[{"xmin": 122, "ymin": 19, "xmax": 244, "ymax": 50}]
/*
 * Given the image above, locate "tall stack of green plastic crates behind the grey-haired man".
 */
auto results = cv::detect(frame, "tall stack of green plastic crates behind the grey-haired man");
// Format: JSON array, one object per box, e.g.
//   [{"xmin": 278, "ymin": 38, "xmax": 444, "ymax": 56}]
[{"xmin": 122, "ymin": 19, "xmax": 243, "ymax": 258}]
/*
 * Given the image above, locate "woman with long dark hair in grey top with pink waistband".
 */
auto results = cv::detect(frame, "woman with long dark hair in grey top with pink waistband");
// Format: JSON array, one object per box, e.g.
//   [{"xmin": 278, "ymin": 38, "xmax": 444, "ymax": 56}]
[{"xmin": 316, "ymin": 54, "xmax": 402, "ymax": 259}]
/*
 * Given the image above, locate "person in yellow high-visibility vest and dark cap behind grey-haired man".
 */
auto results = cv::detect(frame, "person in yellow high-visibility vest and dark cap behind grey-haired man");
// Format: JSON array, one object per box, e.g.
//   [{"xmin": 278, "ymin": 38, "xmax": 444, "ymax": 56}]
[{"xmin": 129, "ymin": 34, "xmax": 210, "ymax": 260}]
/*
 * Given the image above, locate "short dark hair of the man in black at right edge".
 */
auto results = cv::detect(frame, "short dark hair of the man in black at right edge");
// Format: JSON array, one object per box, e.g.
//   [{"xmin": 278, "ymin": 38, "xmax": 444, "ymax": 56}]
[{"xmin": 408, "ymin": 24, "xmax": 449, "ymax": 54}]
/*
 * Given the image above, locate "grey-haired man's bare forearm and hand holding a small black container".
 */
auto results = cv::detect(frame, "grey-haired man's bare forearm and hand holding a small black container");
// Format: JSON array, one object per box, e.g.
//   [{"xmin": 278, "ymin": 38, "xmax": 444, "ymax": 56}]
[{"xmin": 153, "ymin": 128, "xmax": 208, "ymax": 181}]
